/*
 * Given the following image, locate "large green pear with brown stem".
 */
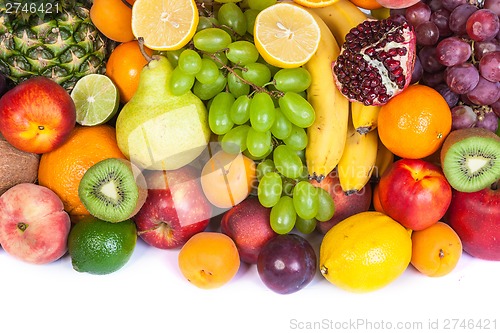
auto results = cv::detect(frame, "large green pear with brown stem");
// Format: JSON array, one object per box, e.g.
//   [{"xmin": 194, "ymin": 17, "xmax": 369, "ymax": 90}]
[{"xmin": 116, "ymin": 56, "xmax": 211, "ymax": 170}]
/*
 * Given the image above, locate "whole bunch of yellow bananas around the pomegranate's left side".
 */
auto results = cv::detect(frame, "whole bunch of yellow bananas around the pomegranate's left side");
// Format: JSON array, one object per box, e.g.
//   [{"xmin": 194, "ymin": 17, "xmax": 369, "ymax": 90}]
[{"xmin": 305, "ymin": 0, "xmax": 394, "ymax": 194}]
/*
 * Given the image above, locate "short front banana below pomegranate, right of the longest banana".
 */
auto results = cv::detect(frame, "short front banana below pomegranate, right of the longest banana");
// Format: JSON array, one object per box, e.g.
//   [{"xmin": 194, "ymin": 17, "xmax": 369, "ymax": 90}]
[{"xmin": 337, "ymin": 114, "xmax": 378, "ymax": 195}]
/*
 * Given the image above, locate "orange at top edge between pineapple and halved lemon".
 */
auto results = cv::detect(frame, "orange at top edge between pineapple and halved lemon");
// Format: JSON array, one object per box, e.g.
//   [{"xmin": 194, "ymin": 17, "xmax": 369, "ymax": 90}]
[{"xmin": 90, "ymin": 0, "xmax": 135, "ymax": 42}]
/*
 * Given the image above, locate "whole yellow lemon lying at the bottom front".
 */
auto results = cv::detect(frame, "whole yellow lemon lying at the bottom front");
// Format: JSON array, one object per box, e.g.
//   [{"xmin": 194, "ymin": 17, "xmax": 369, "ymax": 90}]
[{"xmin": 319, "ymin": 211, "xmax": 412, "ymax": 293}]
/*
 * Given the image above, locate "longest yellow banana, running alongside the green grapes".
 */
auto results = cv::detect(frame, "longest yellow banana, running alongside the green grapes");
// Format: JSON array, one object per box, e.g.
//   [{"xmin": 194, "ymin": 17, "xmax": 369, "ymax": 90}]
[{"xmin": 304, "ymin": 9, "xmax": 349, "ymax": 181}]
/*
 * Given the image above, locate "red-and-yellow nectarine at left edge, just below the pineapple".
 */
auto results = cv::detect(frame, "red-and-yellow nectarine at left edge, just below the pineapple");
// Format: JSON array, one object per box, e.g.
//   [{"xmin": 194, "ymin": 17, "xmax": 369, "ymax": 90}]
[{"xmin": 0, "ymin": 76, "xmax": 76, "ymax": 154}]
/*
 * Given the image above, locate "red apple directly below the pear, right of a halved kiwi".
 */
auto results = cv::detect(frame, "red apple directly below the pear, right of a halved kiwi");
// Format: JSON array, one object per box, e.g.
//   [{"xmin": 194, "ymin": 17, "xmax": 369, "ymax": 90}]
[{"xmin": 133, "ymin": 165, "xmax": 212, "ymax": 249}]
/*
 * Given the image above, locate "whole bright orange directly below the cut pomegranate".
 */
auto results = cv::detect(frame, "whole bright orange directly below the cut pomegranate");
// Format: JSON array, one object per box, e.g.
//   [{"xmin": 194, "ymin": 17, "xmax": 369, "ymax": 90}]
[{"xmin": 378, "ymin": 84, "xmax": 451, "ymax": 159}]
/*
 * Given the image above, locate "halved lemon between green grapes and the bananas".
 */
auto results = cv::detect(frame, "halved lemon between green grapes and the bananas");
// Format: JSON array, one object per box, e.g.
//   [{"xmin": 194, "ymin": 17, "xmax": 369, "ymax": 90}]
[{"xmin": 254, "ymin": 2, "xmax": 321, "ymax": 68}]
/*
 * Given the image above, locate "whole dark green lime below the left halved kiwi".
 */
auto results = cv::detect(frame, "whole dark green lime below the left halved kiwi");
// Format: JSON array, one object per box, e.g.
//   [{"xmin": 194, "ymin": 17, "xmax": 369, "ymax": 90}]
[{"xmin": 68, "ymin": 216, "xmax": 137, "ymax": 275}]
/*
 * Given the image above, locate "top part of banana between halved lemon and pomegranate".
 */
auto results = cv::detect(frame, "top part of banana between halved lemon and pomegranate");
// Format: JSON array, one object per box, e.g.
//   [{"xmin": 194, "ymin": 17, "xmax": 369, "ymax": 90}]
[{"xmin": 312, "ymin": 0, "xmax": 368, "ymax": 46}]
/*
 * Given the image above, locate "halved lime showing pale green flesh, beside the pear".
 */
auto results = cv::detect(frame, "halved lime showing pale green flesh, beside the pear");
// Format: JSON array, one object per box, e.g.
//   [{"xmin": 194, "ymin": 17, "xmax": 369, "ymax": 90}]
[{"xmin": 71, "ymin": 74, "xmax": 120, "ymax": 126}]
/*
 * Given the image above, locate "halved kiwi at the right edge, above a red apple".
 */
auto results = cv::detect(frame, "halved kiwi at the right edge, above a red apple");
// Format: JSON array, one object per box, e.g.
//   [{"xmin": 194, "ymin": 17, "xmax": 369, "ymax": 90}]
[{"xmin": 440, "ymin": 127, "xmax": 500, "ymax": 192}]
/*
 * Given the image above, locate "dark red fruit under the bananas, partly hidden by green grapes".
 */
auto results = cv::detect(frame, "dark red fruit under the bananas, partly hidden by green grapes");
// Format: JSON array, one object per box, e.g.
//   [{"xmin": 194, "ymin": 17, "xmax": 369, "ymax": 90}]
[{"xmin": 310, "ymin": 169, "xmax": 372, "ymax": 234}]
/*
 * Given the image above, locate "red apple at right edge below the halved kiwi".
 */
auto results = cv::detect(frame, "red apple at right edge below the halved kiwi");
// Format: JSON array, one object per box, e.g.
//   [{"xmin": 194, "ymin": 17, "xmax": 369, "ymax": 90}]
[{"xmin": 445, "ymin": 181, "xmax": 500, "ymax": 261}]
